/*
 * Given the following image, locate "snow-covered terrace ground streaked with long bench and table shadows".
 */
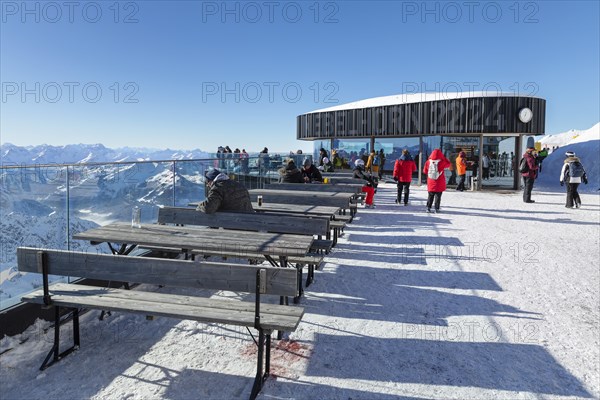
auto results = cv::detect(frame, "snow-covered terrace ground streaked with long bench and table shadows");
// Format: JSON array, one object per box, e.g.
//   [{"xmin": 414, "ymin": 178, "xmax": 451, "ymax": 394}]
[{"xmin": 0, "ymin": 184, "xmax": 600, "ymax": 400}]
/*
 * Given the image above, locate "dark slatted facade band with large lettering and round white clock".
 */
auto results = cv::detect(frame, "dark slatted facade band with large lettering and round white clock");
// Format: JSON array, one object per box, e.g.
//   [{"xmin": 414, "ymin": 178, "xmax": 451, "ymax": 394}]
[{"xmin": 296, "ymin": 96, "xmax": 546, "ymax": 140}]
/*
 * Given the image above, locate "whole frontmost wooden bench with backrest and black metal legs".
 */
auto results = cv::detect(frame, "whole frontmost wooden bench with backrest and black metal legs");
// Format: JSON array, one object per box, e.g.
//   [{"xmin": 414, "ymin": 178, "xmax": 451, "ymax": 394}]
[{"xmin": 17, "ymin": 247, "xmax": 304, "ymax": 399}]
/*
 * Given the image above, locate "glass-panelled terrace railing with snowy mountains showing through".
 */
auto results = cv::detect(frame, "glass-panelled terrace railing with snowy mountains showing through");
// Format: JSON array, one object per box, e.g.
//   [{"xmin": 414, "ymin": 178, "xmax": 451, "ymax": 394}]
[{"xmin": 0, "ymin": 154, "xmax": 292, "ymax": 310}]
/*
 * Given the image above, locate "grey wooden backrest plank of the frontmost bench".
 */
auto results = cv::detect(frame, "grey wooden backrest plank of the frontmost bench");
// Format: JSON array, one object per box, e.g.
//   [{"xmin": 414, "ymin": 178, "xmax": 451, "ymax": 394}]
[{"xmin": 17, "ymin": 247, "xmax": 298, "ymax": 296}]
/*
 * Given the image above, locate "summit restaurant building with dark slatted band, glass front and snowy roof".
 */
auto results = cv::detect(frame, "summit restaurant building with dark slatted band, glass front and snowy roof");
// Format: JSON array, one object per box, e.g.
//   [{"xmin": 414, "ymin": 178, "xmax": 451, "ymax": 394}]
[{"xmin": 296, "ymin": 92, "xmax": 546, "ymax": 190}]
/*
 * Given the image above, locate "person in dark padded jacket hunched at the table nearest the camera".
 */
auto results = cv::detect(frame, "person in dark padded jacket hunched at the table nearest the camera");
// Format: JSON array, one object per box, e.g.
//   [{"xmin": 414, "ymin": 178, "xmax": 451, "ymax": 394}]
[{"xmin": 196, "ymin": 169, "xmax": 254, "ymax": 214}]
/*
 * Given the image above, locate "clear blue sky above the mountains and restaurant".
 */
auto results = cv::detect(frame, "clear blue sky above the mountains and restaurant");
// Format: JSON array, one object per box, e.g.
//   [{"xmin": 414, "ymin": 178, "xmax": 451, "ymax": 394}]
[{"xmin": 0, "ymin": 1, "xmax": 600, "ymax": 151}]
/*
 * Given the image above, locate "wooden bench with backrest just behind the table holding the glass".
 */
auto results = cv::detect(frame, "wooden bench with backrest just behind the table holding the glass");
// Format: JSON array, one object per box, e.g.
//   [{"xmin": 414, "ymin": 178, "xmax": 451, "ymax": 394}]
[{"xmin": 158, "ymin": 207, "xmax": 330, "ymax": 303}]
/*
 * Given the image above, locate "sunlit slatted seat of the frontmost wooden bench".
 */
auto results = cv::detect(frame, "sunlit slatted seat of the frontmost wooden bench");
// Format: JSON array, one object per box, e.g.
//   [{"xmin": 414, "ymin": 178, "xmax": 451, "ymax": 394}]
[{"xmin": 22, "ymin": 283, "xmax": 304, "ymax": 331}]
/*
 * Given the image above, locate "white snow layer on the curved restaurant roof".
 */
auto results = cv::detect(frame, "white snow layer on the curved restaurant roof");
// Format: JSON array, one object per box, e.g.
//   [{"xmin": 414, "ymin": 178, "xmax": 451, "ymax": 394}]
[{"xmin": 307, "ymin": 91, "xmax": 535, "ymax": 114}]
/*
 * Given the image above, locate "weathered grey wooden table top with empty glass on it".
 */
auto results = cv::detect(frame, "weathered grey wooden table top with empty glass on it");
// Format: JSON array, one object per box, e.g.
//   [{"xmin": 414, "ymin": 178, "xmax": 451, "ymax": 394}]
[{"xmin": 73, "ymin": 223, "xmax": 313, "ymax": 256}]
